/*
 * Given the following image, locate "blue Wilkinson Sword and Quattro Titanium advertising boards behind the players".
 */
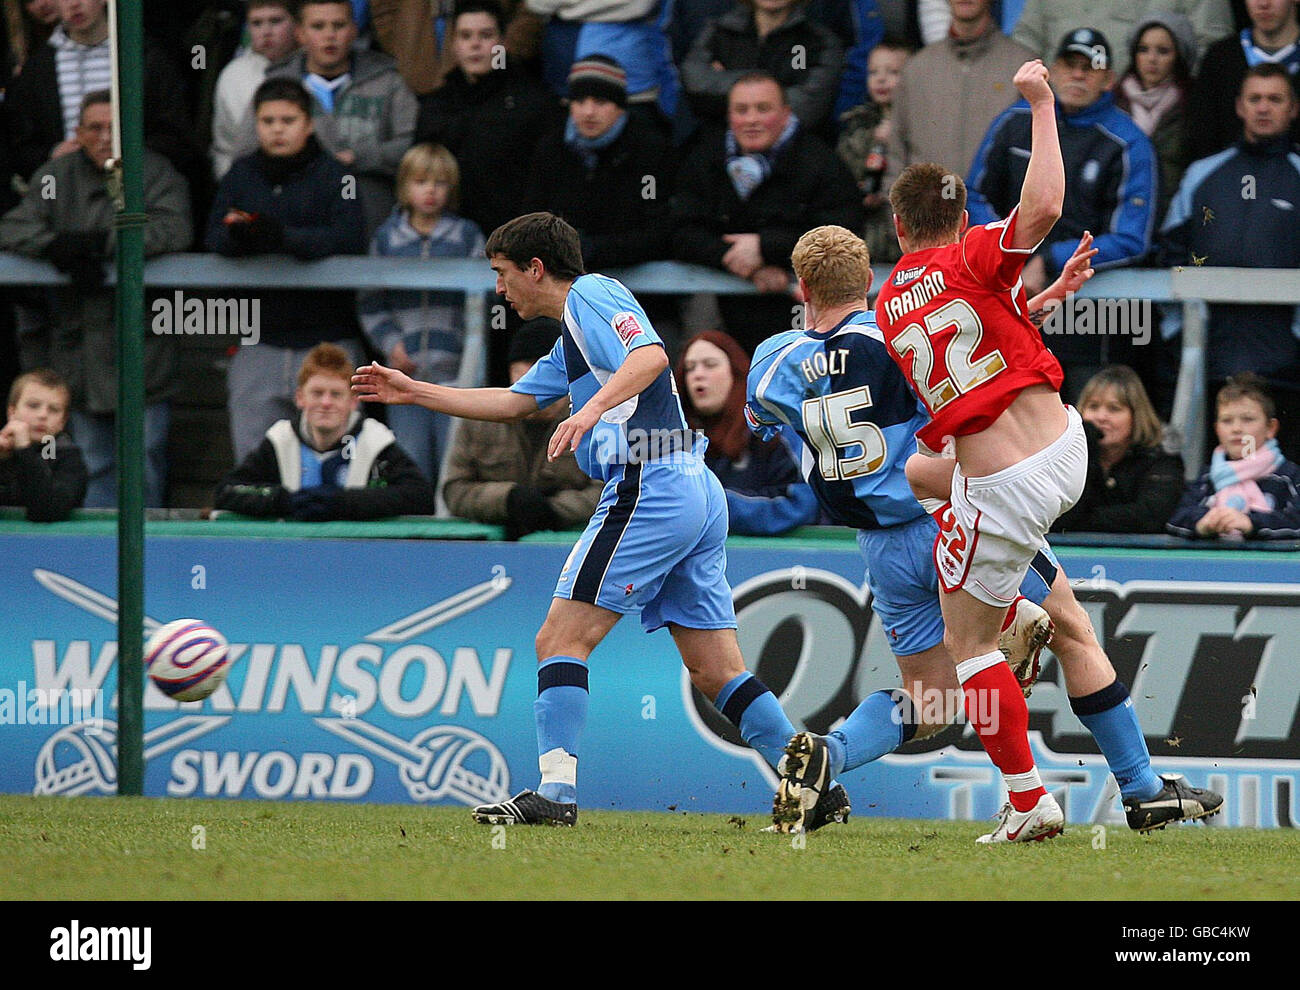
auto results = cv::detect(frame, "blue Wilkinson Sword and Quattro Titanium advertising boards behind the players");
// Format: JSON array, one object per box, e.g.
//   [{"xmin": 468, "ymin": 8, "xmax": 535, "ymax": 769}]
[{"xmin": 0, "ymin": 534, "xmax": 1300, "ymax": 828}]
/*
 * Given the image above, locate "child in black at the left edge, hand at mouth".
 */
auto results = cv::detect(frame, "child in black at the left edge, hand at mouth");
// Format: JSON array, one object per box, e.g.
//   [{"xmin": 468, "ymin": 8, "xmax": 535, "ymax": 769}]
[{"xmin": 0, "ymin": 368, "xmax": 86, "ymax": 522}]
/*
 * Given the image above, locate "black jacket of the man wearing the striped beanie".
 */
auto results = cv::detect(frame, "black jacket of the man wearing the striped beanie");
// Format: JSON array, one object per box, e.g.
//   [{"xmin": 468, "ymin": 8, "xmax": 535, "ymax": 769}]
[{"xmin": 524, "ymin": 114, "xmax": 673, "ymax": 272}]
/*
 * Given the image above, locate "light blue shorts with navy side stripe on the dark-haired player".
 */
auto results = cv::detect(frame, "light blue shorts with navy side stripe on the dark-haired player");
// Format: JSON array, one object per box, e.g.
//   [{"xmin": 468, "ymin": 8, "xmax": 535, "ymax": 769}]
[{"xmin": 555, "ymin": 455, "xmax": 736, "ymax": 633}]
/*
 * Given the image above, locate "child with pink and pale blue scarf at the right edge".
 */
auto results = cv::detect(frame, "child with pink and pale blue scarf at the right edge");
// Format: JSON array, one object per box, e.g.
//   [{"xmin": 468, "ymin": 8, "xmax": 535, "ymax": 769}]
[{"xmin": 1169, "ymin": 372, "xmax": 1300, "ymax": 539}]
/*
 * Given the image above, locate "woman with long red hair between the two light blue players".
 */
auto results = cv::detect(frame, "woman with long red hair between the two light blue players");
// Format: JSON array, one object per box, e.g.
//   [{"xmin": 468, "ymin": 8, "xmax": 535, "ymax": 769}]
[{"xmin": 675, "ymin": 330, "xmax": 818, "ymax": 537}]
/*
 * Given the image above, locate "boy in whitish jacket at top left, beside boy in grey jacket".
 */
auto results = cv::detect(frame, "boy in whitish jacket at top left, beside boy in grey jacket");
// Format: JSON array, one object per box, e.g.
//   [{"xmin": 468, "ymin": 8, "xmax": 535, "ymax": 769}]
[{"xmin": 212, "ymin": 0, "xmax": 298, "ymax": 182}]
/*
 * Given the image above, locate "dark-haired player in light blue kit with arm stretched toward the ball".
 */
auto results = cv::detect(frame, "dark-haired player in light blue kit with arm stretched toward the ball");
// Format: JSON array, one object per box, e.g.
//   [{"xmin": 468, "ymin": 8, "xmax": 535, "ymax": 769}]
[{"xmin": 352, "ymin": 213, "xmax": 826, "ymax": 828}]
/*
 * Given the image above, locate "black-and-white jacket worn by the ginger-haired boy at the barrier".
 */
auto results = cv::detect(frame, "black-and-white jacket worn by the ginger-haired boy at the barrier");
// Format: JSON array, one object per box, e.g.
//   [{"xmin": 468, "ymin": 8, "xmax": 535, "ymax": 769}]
[{"xmin": 215, "ymin": 410, "xmax": 434, "ymax": 521}]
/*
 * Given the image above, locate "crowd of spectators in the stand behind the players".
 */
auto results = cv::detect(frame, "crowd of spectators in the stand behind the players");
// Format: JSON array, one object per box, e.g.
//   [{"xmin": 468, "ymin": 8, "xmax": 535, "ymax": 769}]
[{"xmin": 0, "ymin": 0, "xmax": 1300, "ymax": 537}]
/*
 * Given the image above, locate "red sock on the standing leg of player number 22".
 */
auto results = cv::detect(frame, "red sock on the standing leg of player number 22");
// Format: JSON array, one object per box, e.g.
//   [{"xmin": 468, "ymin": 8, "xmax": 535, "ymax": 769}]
[{"xmin": 957, "ymin": 652, "xmax": 1047, "ymax": 811}]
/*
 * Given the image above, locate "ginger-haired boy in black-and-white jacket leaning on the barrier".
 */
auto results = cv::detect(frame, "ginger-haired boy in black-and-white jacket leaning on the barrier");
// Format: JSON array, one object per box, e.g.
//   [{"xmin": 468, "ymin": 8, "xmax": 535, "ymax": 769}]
[{"xmin": 216, "ymin": 344, "xmax": 434, "ymax": 522}]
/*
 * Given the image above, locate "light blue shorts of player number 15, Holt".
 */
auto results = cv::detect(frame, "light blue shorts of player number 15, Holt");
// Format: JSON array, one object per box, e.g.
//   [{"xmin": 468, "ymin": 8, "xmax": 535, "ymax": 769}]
[{"xmin": 858, "ymin": 516, "xmax": 1060, "ymax": 656}]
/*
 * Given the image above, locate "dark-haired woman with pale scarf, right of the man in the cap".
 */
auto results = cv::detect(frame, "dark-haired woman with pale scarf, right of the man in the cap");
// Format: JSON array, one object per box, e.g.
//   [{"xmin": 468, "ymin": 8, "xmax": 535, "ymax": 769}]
[{"xmin": 1115, "ymin": 13, "xmax": 1196, "ymax": 218}]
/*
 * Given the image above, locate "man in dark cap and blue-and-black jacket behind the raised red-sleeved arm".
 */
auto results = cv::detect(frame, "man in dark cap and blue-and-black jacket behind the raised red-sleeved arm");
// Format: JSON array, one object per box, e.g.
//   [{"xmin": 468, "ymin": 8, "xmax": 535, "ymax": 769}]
[{"xmin": 966, "ymin": 27, "xmax": 1158, "ymax": 400}]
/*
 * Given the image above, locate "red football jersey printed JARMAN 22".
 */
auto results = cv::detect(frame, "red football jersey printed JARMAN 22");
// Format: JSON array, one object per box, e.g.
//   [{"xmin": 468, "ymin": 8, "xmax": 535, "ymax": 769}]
[{"xmin": 876, "ymin": 210, "xmax": 1062, "ymax": 451}]
